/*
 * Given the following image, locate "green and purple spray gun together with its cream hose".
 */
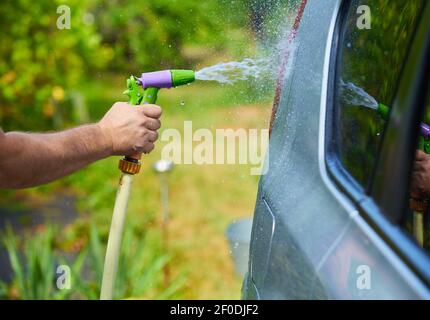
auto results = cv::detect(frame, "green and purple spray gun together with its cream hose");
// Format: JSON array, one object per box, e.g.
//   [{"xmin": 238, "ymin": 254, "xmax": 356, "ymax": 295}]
[{"xmin": 100, "ymin": 70, "xmax": 195, "ymax": 300}]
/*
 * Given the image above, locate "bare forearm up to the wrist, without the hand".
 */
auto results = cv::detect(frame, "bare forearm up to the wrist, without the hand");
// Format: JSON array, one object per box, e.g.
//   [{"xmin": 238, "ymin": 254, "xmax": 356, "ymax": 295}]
[{"xmin": 0, "ymin": 124, "xmax": 112, "ymax": 188}]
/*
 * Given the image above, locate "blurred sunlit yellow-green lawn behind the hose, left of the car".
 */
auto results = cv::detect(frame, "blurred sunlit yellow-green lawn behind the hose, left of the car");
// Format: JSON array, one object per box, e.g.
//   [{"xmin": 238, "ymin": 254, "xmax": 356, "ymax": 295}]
[{"xmin": 1, "ymin": 75, "xmax": 272, "ymax": 299}]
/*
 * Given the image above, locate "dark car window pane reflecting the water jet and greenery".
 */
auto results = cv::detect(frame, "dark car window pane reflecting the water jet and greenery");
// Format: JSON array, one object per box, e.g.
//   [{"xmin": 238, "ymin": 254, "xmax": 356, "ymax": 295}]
[{"xmin": 335, "ymin": 0, "xmax": 423, "ymax": 188}]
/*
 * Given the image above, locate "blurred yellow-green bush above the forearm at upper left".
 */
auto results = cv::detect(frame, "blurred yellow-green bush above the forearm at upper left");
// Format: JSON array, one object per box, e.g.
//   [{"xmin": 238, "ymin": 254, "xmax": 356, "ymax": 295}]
[{"xmin": 0, "ymin": 0, "xmax": 111, "ymax": 129}]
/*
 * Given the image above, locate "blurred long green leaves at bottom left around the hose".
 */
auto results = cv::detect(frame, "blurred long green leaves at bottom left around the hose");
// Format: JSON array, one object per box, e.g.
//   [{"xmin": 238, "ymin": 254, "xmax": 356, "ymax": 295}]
[{"xmin": 0, "ymin": 223, "xmax": 185, "ymax": 300}]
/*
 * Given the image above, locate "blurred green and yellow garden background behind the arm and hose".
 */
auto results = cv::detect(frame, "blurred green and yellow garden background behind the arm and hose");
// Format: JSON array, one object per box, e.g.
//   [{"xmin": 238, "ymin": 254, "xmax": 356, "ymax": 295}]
[{"xmin": 0, "ymin": 0, "xmax": 298, "ymax": 299}]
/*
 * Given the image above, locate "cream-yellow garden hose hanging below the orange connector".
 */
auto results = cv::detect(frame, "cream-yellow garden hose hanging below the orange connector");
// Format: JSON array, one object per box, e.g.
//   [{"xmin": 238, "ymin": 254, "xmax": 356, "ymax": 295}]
[{"xmin": 100, "ymin": 173, "xmax": 133, "ymax": 300}]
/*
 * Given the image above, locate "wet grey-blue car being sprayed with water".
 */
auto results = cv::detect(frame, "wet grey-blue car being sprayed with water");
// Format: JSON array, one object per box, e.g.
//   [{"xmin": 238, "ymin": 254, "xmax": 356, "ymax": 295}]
[{"xmin": 242, "ymin": 0, "xmax": 430, "ymax": 300}]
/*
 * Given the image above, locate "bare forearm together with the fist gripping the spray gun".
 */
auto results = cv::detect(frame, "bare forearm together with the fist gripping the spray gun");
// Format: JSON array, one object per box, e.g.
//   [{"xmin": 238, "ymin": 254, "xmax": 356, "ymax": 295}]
[{"xmin": 0, "ymin": 102, "xmax": 161, "ymax": 188}]
